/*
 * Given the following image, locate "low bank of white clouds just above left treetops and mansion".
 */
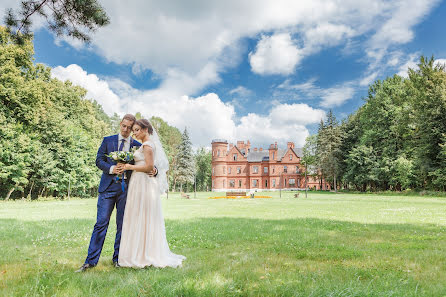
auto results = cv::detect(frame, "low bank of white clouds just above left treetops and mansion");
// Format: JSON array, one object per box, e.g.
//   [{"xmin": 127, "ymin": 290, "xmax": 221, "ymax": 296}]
[{"xmin": 52, "ymin": 65, "xmax": 325, "ymax": 146}]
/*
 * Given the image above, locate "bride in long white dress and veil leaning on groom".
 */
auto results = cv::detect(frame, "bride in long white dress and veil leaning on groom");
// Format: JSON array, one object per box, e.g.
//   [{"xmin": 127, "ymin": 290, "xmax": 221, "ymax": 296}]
[{"xmin": 118, "ymin": 119, "xmax": 186, "ymax": 268}]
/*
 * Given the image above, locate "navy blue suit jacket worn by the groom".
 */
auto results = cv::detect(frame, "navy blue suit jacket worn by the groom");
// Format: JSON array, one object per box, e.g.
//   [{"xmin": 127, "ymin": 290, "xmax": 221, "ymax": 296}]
[{"xmin": 96, "ymin": 134, "xmax": 141, "ymax": 193}]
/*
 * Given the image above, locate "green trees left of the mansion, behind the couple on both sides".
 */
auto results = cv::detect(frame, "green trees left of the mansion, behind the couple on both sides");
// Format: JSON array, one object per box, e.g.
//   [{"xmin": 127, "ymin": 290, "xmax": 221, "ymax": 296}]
[{"xmin": 0, "ymin": 26, "xmax": 211, "ymax": 199}]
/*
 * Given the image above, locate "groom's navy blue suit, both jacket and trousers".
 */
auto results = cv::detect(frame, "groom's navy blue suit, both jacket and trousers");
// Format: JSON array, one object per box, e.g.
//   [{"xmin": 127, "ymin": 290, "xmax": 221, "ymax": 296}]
[{"xmin": 85, "ymin": 135, "xmax": 141, "ymax": 266}]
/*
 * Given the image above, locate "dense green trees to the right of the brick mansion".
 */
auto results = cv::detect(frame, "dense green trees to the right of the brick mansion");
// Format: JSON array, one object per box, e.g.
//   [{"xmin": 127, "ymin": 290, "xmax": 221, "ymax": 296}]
[{"xmin": 304, "ymin": 57, "xmax": 446, "ymax": 191}]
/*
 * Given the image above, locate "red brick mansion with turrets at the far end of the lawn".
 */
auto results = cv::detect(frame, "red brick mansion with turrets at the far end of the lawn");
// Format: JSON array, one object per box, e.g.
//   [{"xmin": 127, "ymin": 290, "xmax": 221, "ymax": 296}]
[{"xmin": 212, "ymin": 139, "xmax": 330, "ymax": 191}]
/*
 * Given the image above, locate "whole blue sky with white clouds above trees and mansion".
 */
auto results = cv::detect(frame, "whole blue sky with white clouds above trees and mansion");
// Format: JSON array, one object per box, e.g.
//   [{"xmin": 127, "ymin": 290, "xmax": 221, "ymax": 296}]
[{"xmin": 0, "ymin": 0, "xmax": 446, "ymax": 147}]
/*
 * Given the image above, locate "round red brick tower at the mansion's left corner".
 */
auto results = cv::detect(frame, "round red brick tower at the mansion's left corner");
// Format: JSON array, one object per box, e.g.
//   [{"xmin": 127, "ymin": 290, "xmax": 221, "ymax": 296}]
[{"xmin": 212, "ymin": 139, "xmax": 228, "ymax": 191}]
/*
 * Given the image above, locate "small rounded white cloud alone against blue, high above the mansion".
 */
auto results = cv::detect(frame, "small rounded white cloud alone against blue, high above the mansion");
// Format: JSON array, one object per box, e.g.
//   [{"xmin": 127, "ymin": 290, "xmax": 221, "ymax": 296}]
[{"xmin": 249, "ymin": 33, "xmax": 301, "ymax": 75}]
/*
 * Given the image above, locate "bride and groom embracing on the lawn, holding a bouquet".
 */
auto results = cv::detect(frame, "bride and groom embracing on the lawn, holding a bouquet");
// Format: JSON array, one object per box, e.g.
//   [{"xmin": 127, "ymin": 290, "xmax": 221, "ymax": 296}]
[{"xmin": 77, "ymin": 114, "xmax": 185, "ymax": 272}]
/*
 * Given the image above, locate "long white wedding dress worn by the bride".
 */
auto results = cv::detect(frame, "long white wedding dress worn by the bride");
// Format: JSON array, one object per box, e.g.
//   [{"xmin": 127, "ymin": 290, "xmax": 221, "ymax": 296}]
[{"xmin": 118, "ymin": 140, "xmax": 186, "ymax": 268}]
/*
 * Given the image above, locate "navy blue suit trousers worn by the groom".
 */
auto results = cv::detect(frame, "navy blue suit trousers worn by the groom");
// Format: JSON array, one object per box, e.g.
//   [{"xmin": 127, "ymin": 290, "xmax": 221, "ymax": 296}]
[{"xmin": 85, "ymin": 182, "xmax": 128, "ymax": 266}]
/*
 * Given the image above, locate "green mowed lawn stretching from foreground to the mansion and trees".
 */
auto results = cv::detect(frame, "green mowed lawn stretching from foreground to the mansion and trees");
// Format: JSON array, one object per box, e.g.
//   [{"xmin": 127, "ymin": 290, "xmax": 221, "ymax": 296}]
[{"xmin": 0, "ymin": 192, "xmax": 446, "ymax": 296}]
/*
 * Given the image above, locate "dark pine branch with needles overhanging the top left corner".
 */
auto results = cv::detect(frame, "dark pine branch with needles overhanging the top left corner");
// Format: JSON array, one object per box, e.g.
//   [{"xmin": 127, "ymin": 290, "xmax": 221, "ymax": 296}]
[{"xmin": 5, "ymin": 0, "xmax": 110, "ymax": 43}]
